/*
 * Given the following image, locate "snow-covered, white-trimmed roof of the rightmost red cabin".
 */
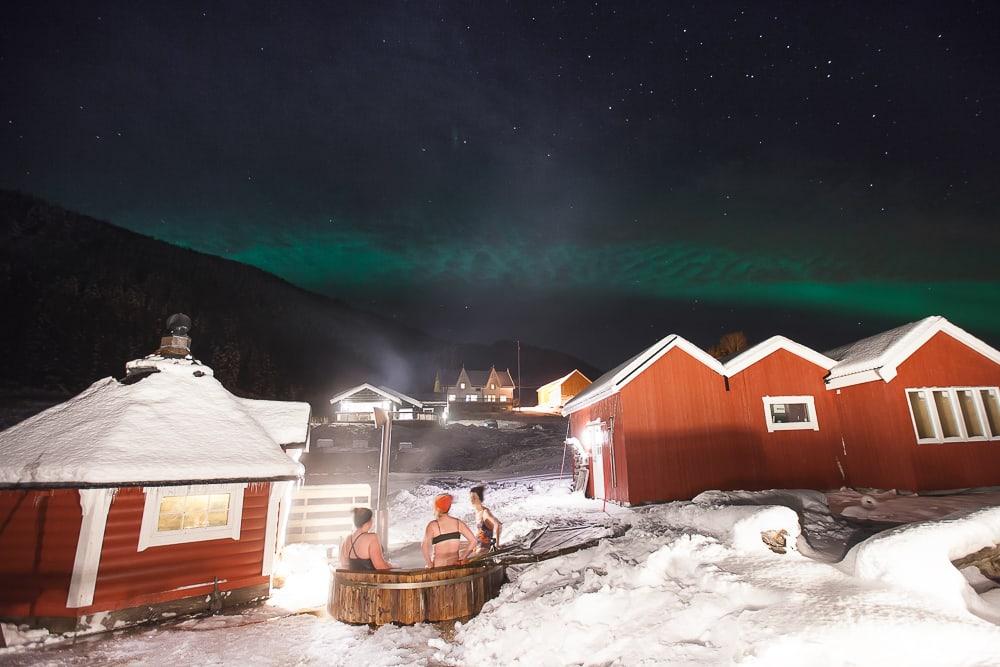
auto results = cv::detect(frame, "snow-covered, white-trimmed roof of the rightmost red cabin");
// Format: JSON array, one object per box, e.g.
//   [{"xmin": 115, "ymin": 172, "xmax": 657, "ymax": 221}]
[{"xmin": 826, "ymin": 315, "xmax": 1000, "ymax": 389}]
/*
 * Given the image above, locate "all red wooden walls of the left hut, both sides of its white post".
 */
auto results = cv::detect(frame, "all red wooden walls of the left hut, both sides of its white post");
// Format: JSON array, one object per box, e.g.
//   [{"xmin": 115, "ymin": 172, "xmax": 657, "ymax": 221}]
[{"xmin": 0, "ymin": 483, "xmax": 270, "ymax": 618}]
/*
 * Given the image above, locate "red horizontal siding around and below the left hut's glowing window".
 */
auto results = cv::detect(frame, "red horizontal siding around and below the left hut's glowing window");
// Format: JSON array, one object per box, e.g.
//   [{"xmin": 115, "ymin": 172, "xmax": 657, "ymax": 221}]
[{"xmin": 81, "ymin": 484, "xmax": 270, "ymax": 613}]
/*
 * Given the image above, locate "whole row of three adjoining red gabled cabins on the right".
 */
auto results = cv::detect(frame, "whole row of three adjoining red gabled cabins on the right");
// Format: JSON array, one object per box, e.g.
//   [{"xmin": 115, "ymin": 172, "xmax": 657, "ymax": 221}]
[{"xmin": 563, "ymin": 317, "xmax": 1000, "ymax": 504}]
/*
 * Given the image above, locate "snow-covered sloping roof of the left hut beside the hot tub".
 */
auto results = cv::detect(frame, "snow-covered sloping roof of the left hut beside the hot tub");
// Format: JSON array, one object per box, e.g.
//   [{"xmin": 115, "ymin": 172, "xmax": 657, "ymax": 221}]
[{"xmin": 0, "ymin": 358, "xmax": 309, "ymax": 487}]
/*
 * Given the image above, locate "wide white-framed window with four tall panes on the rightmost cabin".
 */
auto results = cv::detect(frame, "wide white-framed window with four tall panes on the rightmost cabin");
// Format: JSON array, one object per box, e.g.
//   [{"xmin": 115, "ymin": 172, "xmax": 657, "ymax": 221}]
[{"xmin": 906, "ymin": 387, "xmax": 1000, "ymax": 444}]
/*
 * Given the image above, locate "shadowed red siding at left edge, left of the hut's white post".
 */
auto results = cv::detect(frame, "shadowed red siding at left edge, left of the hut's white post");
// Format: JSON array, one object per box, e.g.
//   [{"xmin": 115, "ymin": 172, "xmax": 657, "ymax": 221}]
[{"xmin": 0, "ymin": 489, "xmax": 82, "ymax": 618}]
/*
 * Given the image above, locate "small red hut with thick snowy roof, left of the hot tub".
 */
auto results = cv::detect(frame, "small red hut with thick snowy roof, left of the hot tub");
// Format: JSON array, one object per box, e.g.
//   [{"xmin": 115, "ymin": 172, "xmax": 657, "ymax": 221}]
[{"xmin": 0, "ymin": 332, "xmax": 309, "ymax": 631}]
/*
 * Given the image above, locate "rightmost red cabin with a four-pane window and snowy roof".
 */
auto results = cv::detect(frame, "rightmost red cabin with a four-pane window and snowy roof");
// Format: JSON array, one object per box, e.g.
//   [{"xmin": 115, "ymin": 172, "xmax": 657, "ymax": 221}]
[{"xmin": 827, "ymin": 317, "xmax": 1000, "ymax": 491}]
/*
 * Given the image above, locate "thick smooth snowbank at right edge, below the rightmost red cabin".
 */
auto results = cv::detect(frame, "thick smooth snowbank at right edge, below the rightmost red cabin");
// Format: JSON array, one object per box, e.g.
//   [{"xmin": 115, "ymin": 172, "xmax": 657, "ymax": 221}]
[{"xmin": 841, "ymin": 507, "xmax": 1000, "ymax": 623}]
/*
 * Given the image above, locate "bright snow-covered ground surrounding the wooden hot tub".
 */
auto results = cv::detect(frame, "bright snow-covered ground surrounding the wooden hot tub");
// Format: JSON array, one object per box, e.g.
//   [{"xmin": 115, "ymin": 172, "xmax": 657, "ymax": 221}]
[{"xmin": 0, "ymin": 436, "xmax": 1000, "ymax": 667}]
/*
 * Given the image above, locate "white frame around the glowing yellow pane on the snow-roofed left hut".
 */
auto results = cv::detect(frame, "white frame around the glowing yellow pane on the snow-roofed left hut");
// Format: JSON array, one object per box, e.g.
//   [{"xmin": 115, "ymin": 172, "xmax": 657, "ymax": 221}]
[{"xmin": 138, "ymin": 483, "xmax": 247, "ymax": 551}]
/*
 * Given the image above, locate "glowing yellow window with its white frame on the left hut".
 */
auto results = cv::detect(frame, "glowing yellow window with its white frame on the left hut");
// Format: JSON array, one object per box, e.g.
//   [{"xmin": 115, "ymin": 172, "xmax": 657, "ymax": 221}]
[{"xmin": 139, "ymin": 484, "xmax": 246, "ymax": 551}]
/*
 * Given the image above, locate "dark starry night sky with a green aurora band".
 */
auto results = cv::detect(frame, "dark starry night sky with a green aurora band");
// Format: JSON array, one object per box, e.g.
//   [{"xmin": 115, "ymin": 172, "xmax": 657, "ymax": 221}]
[{"xmin": 0, "ymin": 0, "xmax": 1000, "ymax": 366}]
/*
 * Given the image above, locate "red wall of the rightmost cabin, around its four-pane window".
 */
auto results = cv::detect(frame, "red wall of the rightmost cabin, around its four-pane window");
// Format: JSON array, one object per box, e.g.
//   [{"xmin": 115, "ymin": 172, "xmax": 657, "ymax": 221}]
[{"xmin": 831, "ymin": 332, "xmax": 1000, "ymax": 491}]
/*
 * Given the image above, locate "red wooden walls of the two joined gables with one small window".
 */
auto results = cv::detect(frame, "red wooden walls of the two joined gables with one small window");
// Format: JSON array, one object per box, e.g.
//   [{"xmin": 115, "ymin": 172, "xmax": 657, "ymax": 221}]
[{"xmin": 570, "ymin": 348, "xmax": 843, "ymax": 504}]
